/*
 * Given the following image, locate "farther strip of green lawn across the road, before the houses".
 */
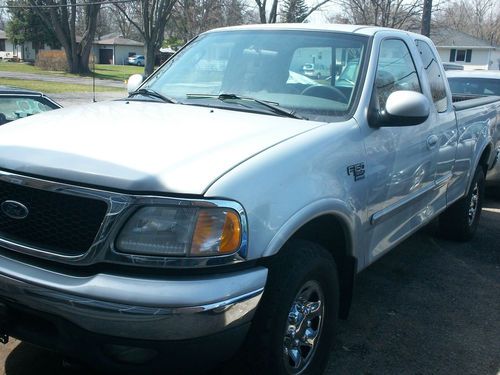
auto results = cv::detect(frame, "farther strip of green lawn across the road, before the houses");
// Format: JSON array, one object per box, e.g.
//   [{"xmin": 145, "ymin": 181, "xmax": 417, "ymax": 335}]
[{"xmin": 0, "ymin": 61, "xmax": 144, "ymax": 81}]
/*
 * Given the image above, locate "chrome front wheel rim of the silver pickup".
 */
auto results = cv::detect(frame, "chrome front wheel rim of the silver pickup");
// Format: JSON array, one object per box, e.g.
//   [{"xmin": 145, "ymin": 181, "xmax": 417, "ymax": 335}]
[{"xmin": 283, "ymin": 280, "xmax": 325, "ymax": 374}]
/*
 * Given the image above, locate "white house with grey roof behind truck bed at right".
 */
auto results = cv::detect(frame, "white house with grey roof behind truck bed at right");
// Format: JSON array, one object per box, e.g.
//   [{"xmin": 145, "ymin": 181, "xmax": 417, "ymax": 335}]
[{"xmin": 430, "ymin": 27, "xmax": 500, "ymax": 70}]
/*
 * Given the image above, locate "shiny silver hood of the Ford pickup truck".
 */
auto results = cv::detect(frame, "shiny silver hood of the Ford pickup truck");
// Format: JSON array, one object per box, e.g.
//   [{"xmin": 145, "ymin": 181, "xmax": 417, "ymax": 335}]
[{"xmin": 0, "ymin": 101, "xmax": 321, "ymax": 194}]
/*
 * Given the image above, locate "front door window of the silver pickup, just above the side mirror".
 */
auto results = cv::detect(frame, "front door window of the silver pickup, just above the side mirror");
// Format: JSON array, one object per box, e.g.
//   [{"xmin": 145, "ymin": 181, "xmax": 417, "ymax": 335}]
[{"xmin": 375, "ymin": 39, "xmax": 422, "ymax": 109}]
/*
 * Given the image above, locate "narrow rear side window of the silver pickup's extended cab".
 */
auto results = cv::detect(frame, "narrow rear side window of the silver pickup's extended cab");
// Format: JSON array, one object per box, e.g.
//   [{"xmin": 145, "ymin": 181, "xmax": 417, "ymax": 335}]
[{"xmin": 415, "ymin": 40, "xmax": 448, "ymax": 112}]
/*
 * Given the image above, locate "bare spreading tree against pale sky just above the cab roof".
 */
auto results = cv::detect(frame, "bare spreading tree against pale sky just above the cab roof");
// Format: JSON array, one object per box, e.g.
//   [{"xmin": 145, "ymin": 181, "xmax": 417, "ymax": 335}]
[{"xmin": 334, "ymin": 0, "xmax": 422, "ymax": 29}]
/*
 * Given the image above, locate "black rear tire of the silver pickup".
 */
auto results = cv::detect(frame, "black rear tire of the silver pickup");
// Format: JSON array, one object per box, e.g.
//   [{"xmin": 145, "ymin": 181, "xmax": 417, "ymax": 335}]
[{"xmin": 439, "ymin": 166, "xmax": 485, "ymax": 241}]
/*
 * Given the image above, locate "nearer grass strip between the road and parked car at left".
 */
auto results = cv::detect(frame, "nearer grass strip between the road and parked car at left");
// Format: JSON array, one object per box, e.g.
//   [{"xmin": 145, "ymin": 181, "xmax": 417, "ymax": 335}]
[{"xmin": 0, "ymin": 78, "xmax": 125, "ymax": 94}]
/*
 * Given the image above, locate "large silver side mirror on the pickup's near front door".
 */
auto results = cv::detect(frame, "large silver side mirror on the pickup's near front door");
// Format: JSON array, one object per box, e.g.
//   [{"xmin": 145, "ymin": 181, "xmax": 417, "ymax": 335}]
[{"xmin": 370, "ymin": 90, "xmax": 430, "ymax": 127}]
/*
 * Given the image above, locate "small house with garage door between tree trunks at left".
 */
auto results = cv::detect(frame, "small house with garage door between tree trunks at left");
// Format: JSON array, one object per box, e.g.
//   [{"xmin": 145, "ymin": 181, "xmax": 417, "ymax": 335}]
[{"xmin": 92, "ymin": 35, "xmax": 144, "ymax": 65}]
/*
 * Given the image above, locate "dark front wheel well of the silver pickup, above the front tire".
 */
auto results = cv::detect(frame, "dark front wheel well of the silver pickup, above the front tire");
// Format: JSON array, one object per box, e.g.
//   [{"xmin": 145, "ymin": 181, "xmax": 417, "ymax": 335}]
[{"xmin": 291, "ymin": 215, "xmax": 357, "ymax": 319}]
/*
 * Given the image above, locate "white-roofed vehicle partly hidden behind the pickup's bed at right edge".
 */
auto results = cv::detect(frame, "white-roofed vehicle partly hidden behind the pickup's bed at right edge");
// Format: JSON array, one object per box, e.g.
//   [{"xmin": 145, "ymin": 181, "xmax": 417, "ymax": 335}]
[{"xmin": 446, "ymin": 70, "xmax": 500, "ymax": 186}]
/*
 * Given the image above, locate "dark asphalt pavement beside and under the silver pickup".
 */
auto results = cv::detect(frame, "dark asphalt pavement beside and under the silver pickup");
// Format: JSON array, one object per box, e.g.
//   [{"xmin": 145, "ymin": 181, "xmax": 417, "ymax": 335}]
[{"xmin": 0, "ymin": 191, "xmax": 500, "ymax": 375}]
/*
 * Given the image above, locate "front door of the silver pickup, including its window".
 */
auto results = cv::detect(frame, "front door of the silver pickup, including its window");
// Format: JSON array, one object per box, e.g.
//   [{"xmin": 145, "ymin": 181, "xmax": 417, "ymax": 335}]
[{"xmin": 364, "ymin": 37, "xmax": 437, "ymax": 263}]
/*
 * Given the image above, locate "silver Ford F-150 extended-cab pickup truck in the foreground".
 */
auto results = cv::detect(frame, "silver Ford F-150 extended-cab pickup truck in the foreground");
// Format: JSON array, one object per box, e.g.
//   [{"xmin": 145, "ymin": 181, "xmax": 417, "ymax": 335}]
[{"xmin": 0, "ymin": 24, "xmax": 499, "ymax": 375}]
